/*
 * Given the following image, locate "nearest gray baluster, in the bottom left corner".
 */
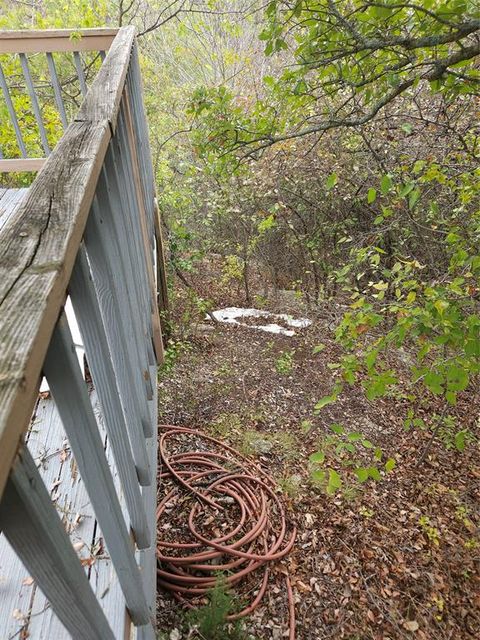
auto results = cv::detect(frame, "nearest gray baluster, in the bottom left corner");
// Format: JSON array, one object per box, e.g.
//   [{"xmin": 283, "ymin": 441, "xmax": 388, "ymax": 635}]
[{"xmin": 0, "ymin": 447, "xmax": 115, "ymax": 640}]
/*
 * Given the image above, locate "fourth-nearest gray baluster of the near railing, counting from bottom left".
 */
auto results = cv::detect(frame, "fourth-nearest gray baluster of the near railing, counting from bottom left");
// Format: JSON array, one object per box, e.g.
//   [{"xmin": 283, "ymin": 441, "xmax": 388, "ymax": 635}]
[{"xmin": 84, "ymin": 196, "xmax": 151, "ymax": 485}]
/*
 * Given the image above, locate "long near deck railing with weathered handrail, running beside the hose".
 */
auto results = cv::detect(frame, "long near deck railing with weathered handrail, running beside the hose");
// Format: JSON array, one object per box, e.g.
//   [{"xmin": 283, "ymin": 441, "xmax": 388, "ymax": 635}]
[{"xmin": 0, "ymin": 27, "xmax": 165, "ymax": 640}]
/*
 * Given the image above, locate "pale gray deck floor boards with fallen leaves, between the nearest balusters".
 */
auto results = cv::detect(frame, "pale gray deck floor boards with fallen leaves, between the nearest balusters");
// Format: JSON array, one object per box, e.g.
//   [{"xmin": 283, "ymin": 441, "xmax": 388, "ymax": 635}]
[{"xmin": 0, "ymin": 393, "xmax": 128, "ymax": 640}]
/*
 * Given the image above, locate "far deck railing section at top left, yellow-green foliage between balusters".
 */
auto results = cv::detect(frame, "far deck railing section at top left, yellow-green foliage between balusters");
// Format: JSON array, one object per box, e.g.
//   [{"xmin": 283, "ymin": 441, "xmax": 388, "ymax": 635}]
[{"xmin": 0, "ymin": 29, "xmax": 117, "ymax": 172}]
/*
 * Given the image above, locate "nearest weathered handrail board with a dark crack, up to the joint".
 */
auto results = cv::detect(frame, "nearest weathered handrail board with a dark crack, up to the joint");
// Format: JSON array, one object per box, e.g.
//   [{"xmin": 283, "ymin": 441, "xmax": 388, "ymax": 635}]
[{"xmin": 0, "ymin": 122, "xmax": 110, "ymax": 500}]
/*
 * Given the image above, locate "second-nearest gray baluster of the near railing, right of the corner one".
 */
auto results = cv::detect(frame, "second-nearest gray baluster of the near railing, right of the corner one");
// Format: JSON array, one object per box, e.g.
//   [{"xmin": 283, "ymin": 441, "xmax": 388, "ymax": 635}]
[{"xmin": 44, "ymin": 314, "xmax": 150, "ymax": 625}]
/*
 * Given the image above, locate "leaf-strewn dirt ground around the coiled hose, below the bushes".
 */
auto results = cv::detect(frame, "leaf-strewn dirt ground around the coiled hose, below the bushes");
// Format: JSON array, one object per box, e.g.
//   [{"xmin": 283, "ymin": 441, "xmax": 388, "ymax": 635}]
[{"xmin": 159, "ymin": 264, "xmax": 480, "ymax": 640}]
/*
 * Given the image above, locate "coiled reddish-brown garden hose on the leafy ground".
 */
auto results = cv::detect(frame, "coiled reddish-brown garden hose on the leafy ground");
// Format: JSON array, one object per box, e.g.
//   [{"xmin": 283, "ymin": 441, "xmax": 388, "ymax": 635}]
[{"xmin": 157, "ymin": 425, "xmax": 296, "ymax": 640}]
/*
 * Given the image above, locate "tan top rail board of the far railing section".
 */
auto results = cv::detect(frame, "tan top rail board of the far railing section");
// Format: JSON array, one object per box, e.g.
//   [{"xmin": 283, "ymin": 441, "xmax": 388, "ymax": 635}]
[{"xmin": 0, "ymin": 29, "xmax": 118, "ymax": 54}]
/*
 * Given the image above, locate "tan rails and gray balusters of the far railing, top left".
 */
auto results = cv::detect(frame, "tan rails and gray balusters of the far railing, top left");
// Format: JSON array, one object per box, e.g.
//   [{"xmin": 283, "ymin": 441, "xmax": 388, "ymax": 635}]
[{"xmin": 0, "ymin": 29, "xmax": 118, "ymax": 173}]
